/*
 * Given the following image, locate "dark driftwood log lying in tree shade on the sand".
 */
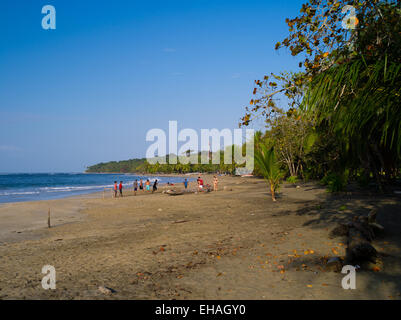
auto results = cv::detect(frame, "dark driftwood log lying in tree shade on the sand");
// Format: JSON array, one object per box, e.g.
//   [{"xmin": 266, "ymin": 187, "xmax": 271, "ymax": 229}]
[{"xmin": 330, "ymin": 210, "xmax": 384, "ymax": 266}]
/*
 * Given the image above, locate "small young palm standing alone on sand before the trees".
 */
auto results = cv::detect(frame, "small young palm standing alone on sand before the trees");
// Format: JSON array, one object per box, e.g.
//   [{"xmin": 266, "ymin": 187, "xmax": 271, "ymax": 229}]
[{"xmin": 255, "ymin": 142, "xmax": 281, "ymax": 201}]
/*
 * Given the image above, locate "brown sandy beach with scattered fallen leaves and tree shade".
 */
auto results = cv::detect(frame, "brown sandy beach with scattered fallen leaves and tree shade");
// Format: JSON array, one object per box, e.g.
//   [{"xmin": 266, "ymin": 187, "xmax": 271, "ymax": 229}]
[{"xmin": 0, "ymin": 175, "xmax": 401, "ymax": 299}]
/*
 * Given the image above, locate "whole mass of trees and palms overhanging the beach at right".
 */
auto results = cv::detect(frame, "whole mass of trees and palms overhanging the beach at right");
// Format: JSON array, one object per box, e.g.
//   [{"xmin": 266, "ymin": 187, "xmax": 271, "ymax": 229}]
[{"xmin": 241, "ymin": 0, "xmax": 401, "ymax": 192}]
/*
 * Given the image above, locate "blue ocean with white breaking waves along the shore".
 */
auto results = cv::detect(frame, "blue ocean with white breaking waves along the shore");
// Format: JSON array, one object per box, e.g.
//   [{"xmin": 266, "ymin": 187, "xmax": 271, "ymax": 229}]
[{"xmin": 0, "ymin": 173, "xmax": 186, "ymax": 203}]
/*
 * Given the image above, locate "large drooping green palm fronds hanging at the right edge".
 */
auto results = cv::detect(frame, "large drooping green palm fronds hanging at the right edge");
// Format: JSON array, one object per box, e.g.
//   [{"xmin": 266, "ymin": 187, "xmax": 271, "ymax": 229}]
[{"xmin": 304, "ymin": 57, "xmax": 401, "ymax": 153}]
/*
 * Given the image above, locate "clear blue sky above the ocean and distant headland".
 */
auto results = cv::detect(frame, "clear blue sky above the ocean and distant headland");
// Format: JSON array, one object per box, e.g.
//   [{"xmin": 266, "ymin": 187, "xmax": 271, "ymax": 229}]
[{"xmin": 0, "ymin": 0, "xmax": 303, "ymax": 172}]
